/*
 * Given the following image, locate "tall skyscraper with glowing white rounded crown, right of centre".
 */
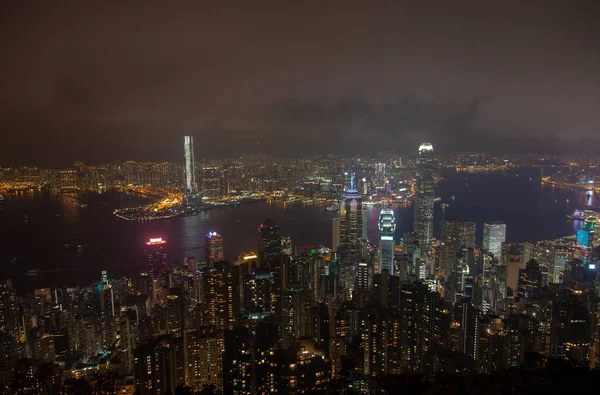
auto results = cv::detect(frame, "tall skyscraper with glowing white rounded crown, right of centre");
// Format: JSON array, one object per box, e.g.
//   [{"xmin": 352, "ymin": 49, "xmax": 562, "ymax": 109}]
[{"xmin": 414, "ymin": 143, "xmax": 435, "ymax": 252}]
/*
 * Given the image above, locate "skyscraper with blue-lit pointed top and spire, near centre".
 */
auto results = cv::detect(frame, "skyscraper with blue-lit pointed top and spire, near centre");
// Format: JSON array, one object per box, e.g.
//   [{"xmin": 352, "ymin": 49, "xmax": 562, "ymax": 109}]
[{"xmin": 339, "ymin": 174, "xmax": 363, "ymax": 297}]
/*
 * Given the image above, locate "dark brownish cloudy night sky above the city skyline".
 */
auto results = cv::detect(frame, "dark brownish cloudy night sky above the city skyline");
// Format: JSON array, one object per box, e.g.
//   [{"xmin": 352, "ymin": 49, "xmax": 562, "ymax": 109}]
[{"xmin": 0, "ymin": 0, "xmax": 600, "ymax": 166}]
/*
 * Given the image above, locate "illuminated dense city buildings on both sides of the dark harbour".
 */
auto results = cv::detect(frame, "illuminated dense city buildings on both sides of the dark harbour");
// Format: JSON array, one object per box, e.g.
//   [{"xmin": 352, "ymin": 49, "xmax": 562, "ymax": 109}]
[{"xmin": 0, "ymin": 141, "xmax": 600, "ymax": 395}]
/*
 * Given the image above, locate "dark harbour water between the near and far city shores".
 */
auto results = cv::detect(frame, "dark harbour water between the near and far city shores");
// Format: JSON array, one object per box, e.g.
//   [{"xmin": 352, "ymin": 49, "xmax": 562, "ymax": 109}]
[{"xmin": 0, "ymin": 169, "xmax": 600, "ymax": 292}]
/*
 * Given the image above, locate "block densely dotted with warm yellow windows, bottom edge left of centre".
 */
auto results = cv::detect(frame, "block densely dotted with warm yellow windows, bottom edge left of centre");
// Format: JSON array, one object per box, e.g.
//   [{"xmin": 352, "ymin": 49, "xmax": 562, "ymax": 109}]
[{"xmin": 183, "ymin": 327, "xmax": 224, "ymax": 391}]
